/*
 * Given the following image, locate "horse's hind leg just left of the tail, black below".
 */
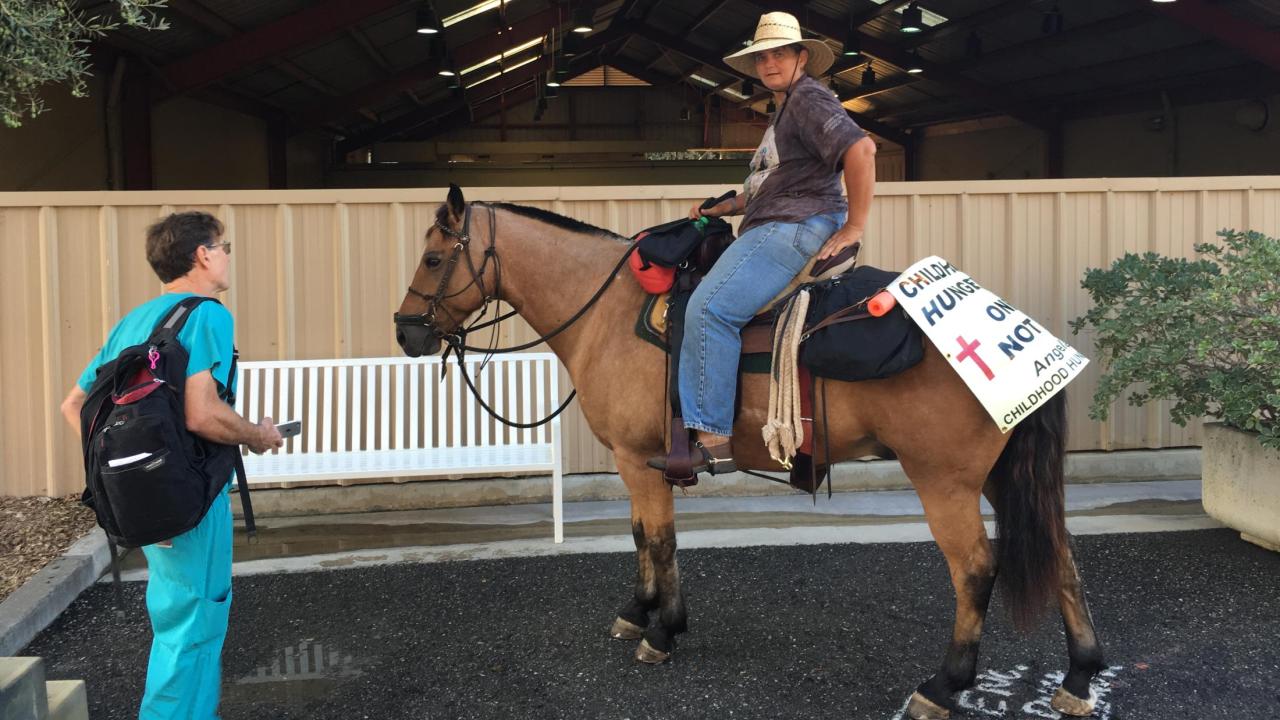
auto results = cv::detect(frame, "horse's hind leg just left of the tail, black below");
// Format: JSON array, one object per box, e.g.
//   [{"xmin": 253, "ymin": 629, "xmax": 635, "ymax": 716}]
[{"xmin": 906, "ymin": 483, "xmax": 996, "ymax": 720}]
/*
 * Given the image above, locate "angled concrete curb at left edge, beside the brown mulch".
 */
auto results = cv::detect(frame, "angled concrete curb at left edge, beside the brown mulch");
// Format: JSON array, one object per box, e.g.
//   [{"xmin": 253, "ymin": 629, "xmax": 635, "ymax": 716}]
[{"xmin": 0, "ymin": 528, "xmax": 110, "ymax": 657}]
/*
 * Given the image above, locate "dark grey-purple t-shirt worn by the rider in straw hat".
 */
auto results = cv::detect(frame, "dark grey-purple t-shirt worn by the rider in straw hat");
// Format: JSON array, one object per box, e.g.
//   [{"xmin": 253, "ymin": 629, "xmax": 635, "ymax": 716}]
[{"xmin": 739, "ymin": 76, "xmax": 867, "ymax": 234}]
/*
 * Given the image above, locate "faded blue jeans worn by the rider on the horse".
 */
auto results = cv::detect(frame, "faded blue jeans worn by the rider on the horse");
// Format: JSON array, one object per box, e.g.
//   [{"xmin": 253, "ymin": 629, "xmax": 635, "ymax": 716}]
[{"xmin": 680, "ymin": 207, "xmax": 846, "ymax": 436}]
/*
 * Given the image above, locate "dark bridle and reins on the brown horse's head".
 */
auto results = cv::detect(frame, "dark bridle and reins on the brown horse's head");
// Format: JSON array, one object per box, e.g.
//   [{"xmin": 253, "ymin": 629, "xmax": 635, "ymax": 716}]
[{"xmin": 392, "ymin": 198, "xmax": 636, "ymax": 429}]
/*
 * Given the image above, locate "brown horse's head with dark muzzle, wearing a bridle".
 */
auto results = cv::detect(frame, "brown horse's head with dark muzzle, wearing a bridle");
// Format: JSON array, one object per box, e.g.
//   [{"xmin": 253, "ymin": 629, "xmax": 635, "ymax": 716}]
[{"xmin": 394, "ymin": 184, "xmax": 497, "ymax": 357}]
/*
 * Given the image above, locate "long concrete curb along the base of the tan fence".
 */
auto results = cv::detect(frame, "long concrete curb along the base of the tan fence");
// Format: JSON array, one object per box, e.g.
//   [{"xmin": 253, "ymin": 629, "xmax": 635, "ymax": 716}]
[{"xmin": 232, "ymin": 447, "xmax": 1201, "ymax": 518}]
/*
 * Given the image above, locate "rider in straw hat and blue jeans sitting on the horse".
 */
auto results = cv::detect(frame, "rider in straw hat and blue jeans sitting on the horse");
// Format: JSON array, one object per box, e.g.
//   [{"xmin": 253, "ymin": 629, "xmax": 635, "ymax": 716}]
[{"xmin": 649, "ymin": 13, "xmax": 876, "ymax": 475}]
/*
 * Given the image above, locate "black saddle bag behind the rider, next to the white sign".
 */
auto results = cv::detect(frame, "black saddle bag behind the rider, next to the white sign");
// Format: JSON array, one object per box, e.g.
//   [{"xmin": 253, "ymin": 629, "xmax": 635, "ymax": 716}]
[{"xmin": 800, "ymin": 266, "xmax": 924, "ymax": 382}]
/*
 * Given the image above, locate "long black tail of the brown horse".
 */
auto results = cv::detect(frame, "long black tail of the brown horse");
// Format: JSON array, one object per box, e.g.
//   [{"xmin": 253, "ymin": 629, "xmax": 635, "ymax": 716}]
[{"xmin": 991, "ymin": 392, "xmax": 1068, "ymax": 630}]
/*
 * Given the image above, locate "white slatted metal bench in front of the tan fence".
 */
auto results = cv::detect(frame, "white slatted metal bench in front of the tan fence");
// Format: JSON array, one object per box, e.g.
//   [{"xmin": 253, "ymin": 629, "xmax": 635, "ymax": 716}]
[{"xmin": 236, "ymin": 352, "xmax": 564, "ymax": 542}]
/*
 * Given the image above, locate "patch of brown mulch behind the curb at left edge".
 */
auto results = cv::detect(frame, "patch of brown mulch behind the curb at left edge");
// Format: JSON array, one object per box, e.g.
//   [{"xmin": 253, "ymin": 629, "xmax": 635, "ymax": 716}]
[{"xmin": 0, "ymin": 495, "xmax": 93, "ymax": 601}]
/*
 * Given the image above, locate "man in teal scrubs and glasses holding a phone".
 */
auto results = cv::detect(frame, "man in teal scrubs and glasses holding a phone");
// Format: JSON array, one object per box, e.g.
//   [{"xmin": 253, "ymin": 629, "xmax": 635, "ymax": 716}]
[{"xmin": 61, "ymin": 211, "xmax": 283, "ymax": 720}]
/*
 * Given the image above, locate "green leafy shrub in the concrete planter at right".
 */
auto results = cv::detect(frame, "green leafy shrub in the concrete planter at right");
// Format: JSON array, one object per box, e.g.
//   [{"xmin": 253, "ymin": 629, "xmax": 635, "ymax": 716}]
[{"xmin": 1071, "ymin": 231, "xmax": 1280, "ymax": 447}]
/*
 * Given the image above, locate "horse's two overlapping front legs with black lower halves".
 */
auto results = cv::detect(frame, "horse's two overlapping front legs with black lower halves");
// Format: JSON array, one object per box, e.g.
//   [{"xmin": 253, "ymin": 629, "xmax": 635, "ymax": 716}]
[{"xmin": 611, "ymin": 452, "xmax": 687, "ymax": 662}]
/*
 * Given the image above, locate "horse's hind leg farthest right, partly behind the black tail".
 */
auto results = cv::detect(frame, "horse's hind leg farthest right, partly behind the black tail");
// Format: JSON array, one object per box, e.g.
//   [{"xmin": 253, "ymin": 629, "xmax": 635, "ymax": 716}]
[{"xmin": 1051, "ymin": 546, "xmax": 1103, "ymax": 717}]
